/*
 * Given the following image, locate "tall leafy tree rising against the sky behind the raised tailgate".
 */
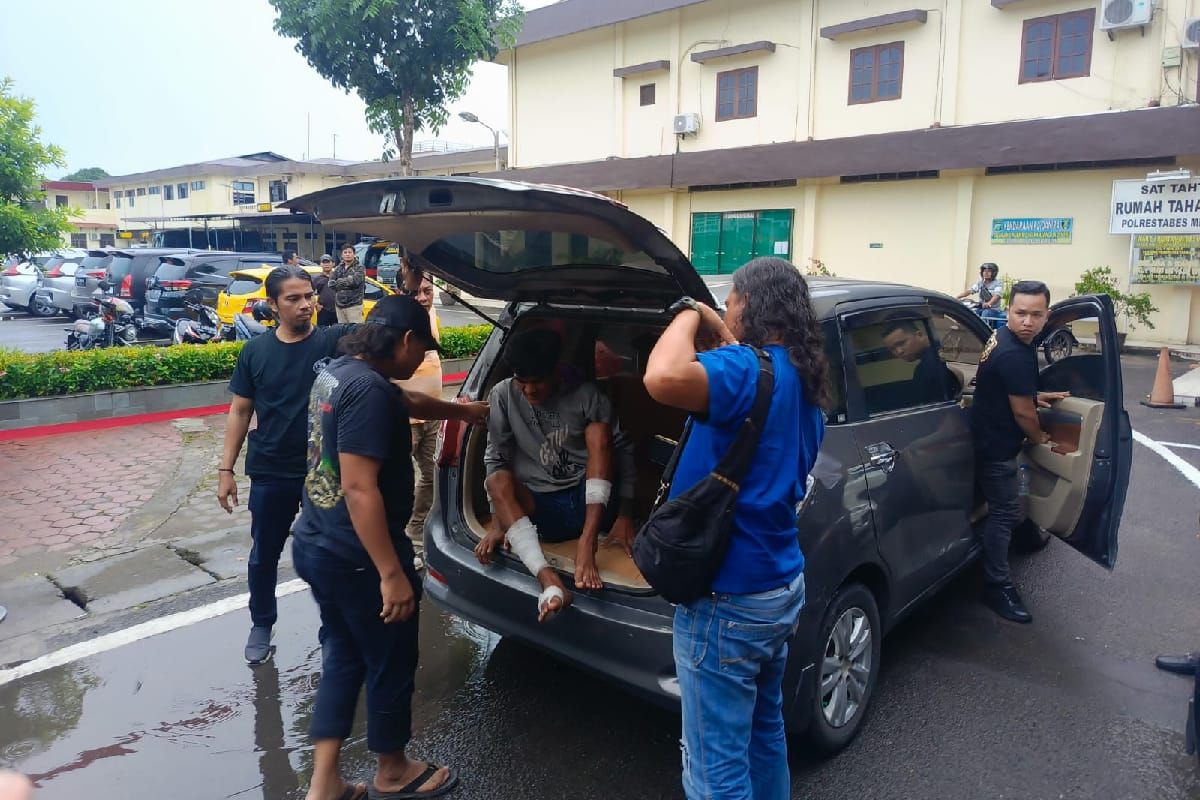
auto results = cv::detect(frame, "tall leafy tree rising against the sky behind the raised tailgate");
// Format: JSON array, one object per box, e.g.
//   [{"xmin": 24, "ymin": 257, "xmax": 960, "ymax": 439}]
[{"xmin": 270, "ymin": 0, "xmax": 523, "ymax": 175}]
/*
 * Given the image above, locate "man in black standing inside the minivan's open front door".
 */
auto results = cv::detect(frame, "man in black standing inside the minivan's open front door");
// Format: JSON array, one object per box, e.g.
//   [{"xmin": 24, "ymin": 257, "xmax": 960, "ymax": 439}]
[{"xmin": 971, "ymin": 281, "xmax": 1067, "ymax": 622}]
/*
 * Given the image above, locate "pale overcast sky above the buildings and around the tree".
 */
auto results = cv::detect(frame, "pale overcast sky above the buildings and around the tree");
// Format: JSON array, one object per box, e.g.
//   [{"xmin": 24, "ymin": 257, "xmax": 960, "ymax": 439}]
[{"xmin": 0, "ymin": 0, "xmax": 551, "ymax": 178}]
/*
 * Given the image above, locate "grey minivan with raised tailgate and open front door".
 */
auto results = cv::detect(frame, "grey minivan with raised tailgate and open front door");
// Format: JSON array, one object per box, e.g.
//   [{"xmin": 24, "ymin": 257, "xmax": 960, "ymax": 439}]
[{"xmin": 287, "ymin": 178, "xmax": 1133, "ymax": 753}]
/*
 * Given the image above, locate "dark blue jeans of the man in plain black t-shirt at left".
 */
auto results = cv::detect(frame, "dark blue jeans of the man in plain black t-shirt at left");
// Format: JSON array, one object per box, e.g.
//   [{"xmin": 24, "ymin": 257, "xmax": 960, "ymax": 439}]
[{"xmin": 246, "ymin": 477, "xmax": 304, "ymax": 627}]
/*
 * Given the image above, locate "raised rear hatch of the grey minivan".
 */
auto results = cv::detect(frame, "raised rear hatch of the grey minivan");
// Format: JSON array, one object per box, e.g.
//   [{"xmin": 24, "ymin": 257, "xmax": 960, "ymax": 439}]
[{"xmin": 283, "ymin": 178, "xmax": 713, "ymax": 308}]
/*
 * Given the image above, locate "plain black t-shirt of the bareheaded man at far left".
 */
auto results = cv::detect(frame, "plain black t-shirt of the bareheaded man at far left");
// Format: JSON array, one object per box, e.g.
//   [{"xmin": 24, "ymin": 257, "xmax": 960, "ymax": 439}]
[{"xmin": 229, "ymin": 325, "xmax": 354, "ymax": 477}]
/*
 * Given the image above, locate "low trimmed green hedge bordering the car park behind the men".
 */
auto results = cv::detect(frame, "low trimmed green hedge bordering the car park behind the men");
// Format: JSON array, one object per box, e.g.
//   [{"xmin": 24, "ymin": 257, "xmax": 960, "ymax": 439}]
[{"xmin": 0, "ymin": 325, "xmax": 492, "ymax": 401}]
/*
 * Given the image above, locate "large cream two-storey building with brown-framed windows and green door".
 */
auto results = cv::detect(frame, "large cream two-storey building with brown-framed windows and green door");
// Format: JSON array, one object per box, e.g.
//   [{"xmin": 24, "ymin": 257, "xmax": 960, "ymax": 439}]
[{"xmin": 499, "ymin": 0, "xmax": 1200, "ymax": 343}]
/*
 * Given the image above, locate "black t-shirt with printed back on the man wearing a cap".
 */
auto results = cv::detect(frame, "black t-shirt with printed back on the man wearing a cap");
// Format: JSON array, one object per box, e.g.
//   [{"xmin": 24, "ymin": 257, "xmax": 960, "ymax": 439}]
[{"xmin": 292, "ymin": 356, "xmax": 413, "ymax": 568}]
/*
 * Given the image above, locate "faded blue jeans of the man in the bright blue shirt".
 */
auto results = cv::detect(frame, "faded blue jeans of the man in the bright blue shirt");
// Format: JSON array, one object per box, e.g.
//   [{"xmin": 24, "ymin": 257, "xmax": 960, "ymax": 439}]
[{"xmin": 673, "ymin": 575, "xmax": 804, "ymax": 800}]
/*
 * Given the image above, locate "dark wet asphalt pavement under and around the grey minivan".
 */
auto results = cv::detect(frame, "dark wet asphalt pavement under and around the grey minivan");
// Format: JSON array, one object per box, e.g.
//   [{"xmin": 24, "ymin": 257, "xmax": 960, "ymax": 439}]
[{"xmin": 0, "ymin": 359, "xmax": 1200, "ymax": 800}]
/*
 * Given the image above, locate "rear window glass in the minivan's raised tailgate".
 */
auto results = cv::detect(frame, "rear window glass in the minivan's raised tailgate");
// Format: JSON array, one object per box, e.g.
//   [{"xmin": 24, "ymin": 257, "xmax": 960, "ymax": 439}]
[{"xmin": 424, "ymin": 229, "xmax": 666, "ymax": 273}]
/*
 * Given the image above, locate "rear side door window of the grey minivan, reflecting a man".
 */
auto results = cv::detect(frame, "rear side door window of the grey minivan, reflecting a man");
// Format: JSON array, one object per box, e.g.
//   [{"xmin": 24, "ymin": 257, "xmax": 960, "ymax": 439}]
[{"xmin": 847, "ymin": 318, "xmax": 961, "ymax": 416}]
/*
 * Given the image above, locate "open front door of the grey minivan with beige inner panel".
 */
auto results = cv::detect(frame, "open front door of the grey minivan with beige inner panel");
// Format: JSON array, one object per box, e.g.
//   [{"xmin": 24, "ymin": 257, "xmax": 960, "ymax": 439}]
[{"xmin": 1021, "ymin": 295, "xmax": 1133, "ymax": 570}]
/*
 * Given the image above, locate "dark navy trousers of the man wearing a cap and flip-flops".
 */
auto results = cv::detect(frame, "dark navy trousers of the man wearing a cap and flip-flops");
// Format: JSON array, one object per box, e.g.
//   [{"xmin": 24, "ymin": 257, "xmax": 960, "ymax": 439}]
[{"xmin": 292, "ymin": 539, "xmax": 421, "ymax": 753}]
